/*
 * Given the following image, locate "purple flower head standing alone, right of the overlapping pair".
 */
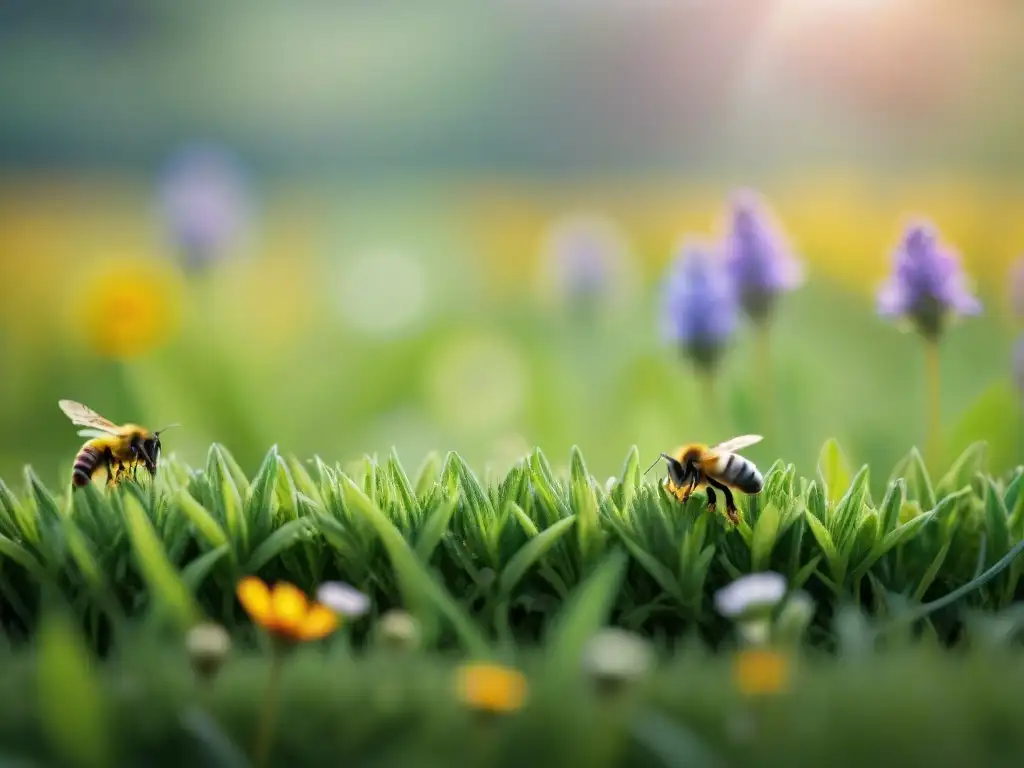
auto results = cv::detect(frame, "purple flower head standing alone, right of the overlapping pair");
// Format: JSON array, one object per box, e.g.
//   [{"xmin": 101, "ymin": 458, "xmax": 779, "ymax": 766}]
[{"xmin": 878, "ymin": 221, "xmax": 981, "ymax": 339}]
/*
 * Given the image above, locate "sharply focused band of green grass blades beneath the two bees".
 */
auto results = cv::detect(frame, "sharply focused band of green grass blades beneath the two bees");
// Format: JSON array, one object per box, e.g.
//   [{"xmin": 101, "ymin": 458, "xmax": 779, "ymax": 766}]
[{"xmin": 0, "ymin": 440, "xmax": 1024, "ymax": 652}]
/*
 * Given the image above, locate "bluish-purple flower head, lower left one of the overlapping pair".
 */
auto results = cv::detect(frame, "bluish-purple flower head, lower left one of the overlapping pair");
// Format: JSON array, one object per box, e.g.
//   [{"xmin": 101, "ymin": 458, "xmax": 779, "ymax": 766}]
[{"xmin": 662, "ymin": 240, "xmax": 738, "ymax": 368}]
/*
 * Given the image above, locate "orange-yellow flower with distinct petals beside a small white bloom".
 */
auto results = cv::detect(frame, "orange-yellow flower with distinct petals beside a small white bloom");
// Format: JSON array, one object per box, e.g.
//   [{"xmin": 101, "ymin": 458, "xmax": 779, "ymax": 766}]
[{"xmin": 237, "ymin": 577, "xmax": 338, "ymax": 643}]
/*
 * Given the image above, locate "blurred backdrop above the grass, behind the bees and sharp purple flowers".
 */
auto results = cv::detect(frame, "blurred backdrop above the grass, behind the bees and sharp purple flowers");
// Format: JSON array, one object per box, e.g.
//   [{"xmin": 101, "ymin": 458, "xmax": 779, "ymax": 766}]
[{"xmin": 0, "ymin": 0, "xmax": 1024, "ymax": 483}]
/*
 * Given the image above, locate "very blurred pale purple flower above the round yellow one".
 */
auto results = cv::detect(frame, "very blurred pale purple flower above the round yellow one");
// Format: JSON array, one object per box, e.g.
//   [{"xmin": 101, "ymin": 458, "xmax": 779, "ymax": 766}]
[{"xmin": 160, "ymin": 143, "xmax": 247, "ymax": 268}]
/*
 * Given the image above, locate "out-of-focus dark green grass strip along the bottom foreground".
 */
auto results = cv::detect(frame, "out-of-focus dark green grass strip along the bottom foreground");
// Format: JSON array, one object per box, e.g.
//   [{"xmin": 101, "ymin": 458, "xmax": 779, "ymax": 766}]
[{"xmin": 6, "ymin": 602, "xmax": 1024, "ymax": 768}]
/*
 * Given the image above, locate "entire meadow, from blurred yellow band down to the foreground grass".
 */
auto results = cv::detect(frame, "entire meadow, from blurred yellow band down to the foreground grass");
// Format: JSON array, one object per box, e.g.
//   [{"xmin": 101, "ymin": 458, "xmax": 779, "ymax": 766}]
[{"xmin": 0, "ymin": 174, "xmax": 1024, "ymax": 766}]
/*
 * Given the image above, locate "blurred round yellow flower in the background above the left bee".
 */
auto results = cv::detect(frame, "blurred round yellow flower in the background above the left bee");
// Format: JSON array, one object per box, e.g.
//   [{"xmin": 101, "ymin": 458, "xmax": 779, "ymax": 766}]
[{"xmin": 76, "ymin": 259, "xmax": 181, "ymax": 359}]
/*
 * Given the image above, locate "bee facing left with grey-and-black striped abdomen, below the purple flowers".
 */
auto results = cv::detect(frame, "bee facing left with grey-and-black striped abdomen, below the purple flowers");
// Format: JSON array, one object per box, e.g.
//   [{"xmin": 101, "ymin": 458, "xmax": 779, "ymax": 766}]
[{"xmin": 645, "ymin": 434, "xmax": 764, "ymax": 523}]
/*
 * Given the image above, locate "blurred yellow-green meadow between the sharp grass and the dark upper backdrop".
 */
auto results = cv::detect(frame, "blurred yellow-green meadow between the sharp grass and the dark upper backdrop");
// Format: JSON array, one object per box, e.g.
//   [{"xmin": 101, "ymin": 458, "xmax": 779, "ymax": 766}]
[{"xmin": 0, "ymin": 172, "xmax": 1024, "ymax": 489}]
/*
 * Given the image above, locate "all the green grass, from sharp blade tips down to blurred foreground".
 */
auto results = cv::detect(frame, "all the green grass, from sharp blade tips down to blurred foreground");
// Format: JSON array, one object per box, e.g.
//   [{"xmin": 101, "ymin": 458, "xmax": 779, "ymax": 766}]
[{"xmin": 0, "ymin": 440, "xmax": 1024, "ymax": 768}]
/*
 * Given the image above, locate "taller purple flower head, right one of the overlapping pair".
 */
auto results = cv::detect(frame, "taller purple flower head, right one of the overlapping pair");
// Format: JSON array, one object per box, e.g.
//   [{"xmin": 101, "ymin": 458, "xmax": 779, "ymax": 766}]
[{"xmin": 724, "ymin": 189, "xmax": 804, "ymax": 323}]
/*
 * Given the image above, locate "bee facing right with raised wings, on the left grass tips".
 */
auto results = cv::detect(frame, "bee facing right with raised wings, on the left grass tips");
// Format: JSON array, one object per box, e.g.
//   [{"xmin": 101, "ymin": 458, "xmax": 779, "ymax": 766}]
[{"xmin": 57, "ymin": 400, "xmax": 177, "ymax": 490}]
